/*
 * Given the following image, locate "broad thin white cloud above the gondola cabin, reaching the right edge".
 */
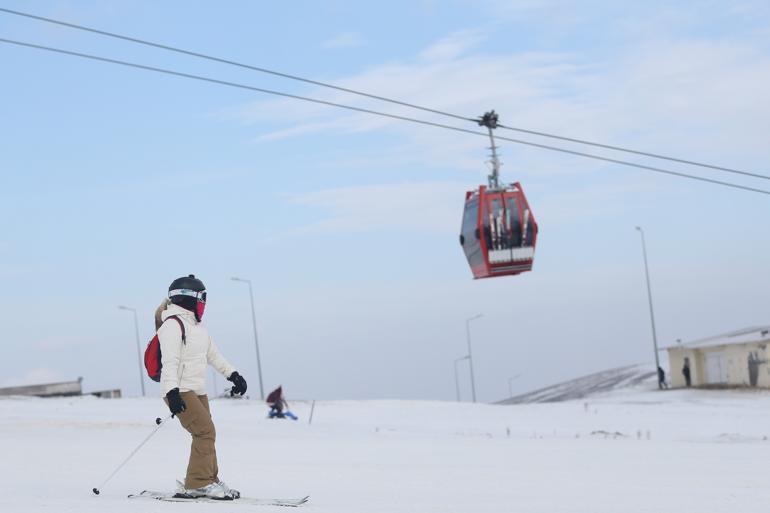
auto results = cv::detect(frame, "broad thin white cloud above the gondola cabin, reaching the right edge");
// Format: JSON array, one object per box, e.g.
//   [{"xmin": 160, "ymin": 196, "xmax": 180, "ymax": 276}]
[{"xmin": 234, "ymin": 27, "xmax": 770, "ymax": 177}]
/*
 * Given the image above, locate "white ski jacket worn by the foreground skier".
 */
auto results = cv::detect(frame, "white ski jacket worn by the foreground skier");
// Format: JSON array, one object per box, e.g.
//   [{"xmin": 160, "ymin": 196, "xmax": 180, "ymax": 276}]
[{"xmin": 158, "ymin": 304, "xmax": 235, "ymax": 397}]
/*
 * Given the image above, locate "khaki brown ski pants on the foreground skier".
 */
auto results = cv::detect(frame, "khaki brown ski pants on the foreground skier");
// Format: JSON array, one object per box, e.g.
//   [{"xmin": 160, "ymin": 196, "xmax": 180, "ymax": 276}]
[{"xmin": 163, "ymin": 392, "xmax": 219, "ymax": 490}]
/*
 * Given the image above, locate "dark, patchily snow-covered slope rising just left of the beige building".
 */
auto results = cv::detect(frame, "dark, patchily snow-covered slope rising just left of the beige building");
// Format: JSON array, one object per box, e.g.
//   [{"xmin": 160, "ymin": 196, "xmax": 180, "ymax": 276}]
[{"xmin": 497, "ymin": 365, "xmax": 657, "ymax": 404}]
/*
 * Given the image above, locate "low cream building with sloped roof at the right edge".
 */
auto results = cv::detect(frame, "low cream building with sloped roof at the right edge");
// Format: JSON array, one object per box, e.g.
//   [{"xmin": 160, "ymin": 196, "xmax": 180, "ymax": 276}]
[{"xmin": 665, "ymin": 326, "xmax": 770, "ymax": 388}]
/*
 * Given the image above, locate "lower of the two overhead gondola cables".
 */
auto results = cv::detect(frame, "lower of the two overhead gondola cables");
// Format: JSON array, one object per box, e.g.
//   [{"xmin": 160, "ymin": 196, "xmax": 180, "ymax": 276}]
[{"xmin": 0, "ymin": 38, "xmax": 770, "ymax": 195}]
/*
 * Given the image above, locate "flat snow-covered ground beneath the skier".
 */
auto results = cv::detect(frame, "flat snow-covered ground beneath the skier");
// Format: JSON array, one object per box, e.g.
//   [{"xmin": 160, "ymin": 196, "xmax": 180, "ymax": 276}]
[{"xmin": 0, "ymin": 382, "xmax": 770, "ymax": 513}]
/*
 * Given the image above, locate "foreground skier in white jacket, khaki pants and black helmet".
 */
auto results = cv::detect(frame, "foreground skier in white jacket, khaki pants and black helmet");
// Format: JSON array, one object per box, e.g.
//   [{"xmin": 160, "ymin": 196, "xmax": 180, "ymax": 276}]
[{"xmin": 158, "ymin": 274, "xmax": 246, "ymax": 499}]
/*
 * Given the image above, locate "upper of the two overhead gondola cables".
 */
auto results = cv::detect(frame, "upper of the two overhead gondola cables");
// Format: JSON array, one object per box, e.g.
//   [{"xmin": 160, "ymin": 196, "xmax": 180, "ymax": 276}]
[{"xmin": 0, "ymin": 7, "xmax": 770, "ymax": 180}]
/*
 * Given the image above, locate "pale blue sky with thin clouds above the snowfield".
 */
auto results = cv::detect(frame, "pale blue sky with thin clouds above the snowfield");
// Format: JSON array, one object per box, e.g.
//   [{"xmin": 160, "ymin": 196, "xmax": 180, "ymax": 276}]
[{"xmin": 0, "ymin": 0, "xmax": 770, "ymax": 401}]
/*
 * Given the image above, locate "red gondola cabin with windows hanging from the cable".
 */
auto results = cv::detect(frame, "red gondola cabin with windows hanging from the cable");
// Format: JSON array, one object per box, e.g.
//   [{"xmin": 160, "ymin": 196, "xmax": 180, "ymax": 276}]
[{"xmin": 460, "ymin": 182, "xmax": 537, "ymax": 278}]
